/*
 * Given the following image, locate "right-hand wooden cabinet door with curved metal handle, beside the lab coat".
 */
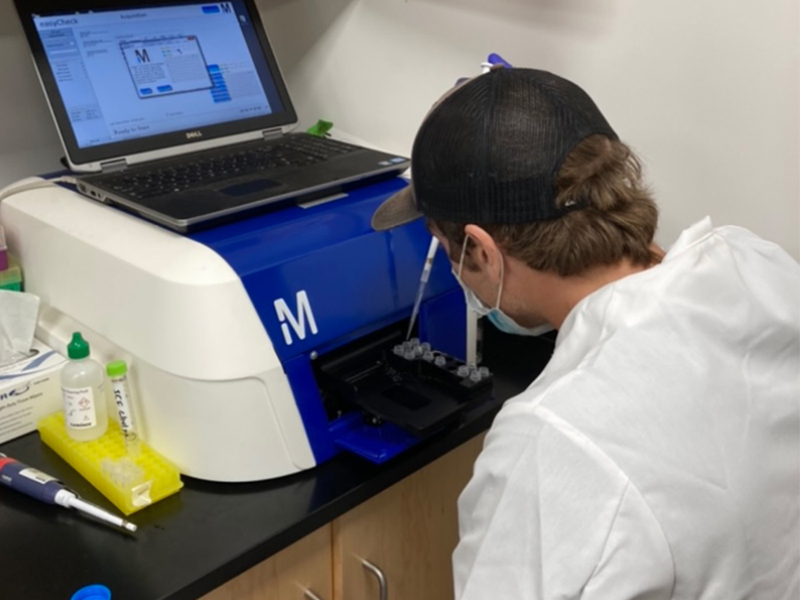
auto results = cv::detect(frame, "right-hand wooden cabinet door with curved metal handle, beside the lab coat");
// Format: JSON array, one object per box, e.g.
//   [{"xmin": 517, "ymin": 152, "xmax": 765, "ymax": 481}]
[{"xmin": 333, "ymin": 436, "xmax": 483, "ymax": 600}]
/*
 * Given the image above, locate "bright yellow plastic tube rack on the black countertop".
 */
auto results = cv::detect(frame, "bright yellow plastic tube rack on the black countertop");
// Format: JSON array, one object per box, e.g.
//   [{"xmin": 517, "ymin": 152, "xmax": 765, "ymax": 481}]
[{"xmin": 38, "ymin": 411, "xmax": 183, "ymax": 515}]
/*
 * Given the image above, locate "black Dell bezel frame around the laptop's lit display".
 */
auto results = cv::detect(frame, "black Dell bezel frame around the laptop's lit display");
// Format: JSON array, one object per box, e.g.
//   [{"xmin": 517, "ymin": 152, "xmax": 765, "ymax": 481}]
[{"xmin": 14, "ymin": 0, "xmax": 297, "ymax": 170}]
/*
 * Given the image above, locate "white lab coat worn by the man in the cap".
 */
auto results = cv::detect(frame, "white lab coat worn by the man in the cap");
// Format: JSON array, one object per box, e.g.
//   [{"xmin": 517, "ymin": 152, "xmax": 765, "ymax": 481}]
[{"xmin": 453, "ymin": 218, "xmax": 800, "ymax": 600}]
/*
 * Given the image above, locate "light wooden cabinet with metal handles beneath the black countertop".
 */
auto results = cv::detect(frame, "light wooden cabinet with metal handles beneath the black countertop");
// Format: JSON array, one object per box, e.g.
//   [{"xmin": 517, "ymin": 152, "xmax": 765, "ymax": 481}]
[{"xmin": 202, "ymin": 435, "xmax": 483, "ymax": 600}]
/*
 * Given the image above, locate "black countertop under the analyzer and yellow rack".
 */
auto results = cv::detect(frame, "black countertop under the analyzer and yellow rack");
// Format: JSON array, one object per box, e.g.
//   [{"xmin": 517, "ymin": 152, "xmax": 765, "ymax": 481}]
[{"xmin": 0, "ymin": 327, "xmax": 552, "ymax": 600}]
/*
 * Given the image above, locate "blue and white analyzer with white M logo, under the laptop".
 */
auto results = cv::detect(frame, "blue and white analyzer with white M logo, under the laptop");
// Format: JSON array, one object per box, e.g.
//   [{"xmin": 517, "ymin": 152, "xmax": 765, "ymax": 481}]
[{"xmin": 0, "ymin": 178, "xmax": 491, "ymax": 481}]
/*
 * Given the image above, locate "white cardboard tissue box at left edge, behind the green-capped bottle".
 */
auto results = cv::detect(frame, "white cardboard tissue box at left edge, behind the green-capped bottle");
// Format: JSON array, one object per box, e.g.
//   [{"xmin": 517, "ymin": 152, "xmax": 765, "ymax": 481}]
[{"xmin": 0, "ymin": 340, "xmax": 67, "ymax": 444}]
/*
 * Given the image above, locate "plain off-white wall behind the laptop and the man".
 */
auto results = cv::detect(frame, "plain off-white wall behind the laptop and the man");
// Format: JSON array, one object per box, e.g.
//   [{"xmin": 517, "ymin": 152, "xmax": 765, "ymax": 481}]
[{"xmin": 0, "ymin": 0, "xmax": 800, "ymax": 257}]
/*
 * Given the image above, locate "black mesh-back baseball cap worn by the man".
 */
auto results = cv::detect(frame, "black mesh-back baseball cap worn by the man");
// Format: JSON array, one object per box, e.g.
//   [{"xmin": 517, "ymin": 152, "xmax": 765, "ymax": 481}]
[{"xmin": 372, "ymin": 68, "xmax": 618, "ymax": 230}]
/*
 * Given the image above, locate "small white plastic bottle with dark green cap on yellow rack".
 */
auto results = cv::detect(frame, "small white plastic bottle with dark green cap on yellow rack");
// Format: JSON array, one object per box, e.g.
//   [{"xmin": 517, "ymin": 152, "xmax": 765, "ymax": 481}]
[{"xmin": 61, "ymin": 332, "xmax": 108, "ymax": 442}]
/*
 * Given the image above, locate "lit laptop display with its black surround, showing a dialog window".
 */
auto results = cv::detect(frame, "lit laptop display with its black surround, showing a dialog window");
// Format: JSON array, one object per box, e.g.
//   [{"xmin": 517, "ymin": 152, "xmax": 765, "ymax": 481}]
[{"xmin": 18, "ymin": 0, "xmax": 295, "ymax": 169}]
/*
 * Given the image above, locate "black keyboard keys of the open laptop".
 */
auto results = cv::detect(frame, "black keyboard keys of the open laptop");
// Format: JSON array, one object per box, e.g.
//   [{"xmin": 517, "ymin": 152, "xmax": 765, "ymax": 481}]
[{"xmin": 102, "ymin": 135, "xmax": 360, "ymax": 200}]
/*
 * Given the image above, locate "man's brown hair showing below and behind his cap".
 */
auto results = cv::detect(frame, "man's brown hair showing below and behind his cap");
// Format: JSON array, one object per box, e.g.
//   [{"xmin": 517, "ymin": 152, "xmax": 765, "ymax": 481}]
[{"xmin": 428, "ymin": 135, "xmax": 659, "ymax": 277}]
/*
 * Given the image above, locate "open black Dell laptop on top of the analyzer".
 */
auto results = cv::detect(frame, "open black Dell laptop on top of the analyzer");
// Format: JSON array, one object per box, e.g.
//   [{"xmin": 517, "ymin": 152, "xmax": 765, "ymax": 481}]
[{"xmin": 15, "ymin": 0, "xmax": 409, "ymax": 233}]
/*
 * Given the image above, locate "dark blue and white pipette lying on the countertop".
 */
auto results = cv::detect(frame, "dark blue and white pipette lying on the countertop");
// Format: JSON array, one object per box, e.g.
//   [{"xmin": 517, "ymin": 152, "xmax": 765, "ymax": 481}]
[{"xmin": 0, "ymin": 453, "xmax": 136, "ymax": 533}]
